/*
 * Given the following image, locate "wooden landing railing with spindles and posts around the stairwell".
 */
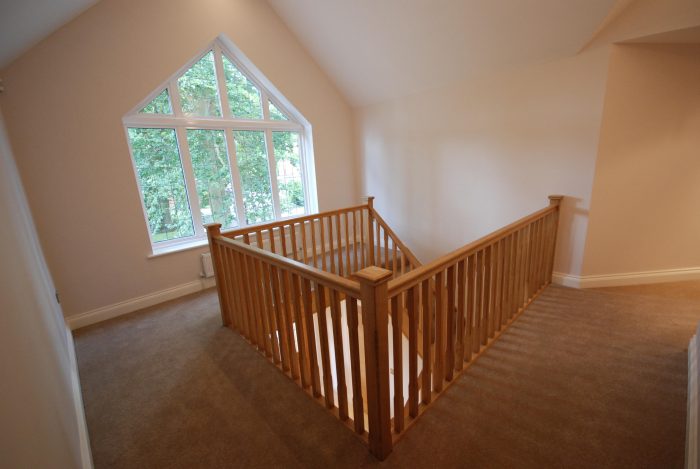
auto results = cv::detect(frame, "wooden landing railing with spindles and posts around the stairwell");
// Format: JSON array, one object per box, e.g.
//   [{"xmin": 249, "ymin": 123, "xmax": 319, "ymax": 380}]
[{"xmin": 207, "ymin": 196, "xmax": 561, "ymax": 459}]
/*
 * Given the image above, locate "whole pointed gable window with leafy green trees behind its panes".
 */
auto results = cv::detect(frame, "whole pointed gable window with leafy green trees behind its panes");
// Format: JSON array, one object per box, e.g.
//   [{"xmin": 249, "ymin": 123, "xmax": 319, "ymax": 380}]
[{"xmin": 124, "ymin": 40, "xmax": 315, "ymax": 250}]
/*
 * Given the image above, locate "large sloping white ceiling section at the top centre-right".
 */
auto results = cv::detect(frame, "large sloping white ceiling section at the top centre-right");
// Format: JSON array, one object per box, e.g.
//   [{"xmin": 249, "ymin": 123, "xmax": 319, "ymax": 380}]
[{"xmin": 268, "ymin": 0, "xmax": 616, "ymax": 106}]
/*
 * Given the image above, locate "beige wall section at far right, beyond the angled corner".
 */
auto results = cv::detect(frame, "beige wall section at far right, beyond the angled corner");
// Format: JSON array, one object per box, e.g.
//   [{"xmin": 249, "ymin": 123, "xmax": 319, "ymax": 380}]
[{"xmin": 584, "ymin": 44, "xmax": 700, "ymax": 275}]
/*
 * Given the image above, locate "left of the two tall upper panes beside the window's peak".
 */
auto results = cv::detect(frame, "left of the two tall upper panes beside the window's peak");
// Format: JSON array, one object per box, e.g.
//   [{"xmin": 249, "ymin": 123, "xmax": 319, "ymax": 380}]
[{"xmin": 177, "ymin": 51, "xmax": 221, "ymax": 117}]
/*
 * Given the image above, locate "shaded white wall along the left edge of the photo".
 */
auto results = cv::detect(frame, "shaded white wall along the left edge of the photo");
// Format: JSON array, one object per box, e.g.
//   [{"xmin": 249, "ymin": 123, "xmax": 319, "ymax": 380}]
[{"xmin": 0, "ymin": 109, "xmax": 92, "ymax": 468}]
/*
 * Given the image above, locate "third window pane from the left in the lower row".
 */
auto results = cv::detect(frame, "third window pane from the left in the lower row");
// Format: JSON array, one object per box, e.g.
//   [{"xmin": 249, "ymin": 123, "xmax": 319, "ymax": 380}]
[{"xmin": 233, "ymin": 130, "xmax": 274, "ymax": 224}]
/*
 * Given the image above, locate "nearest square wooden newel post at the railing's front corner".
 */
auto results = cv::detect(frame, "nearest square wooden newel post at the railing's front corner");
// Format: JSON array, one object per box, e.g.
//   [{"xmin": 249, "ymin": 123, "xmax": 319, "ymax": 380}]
[{"xmin": 355, "ymin": 266, "xmax": 392, "ymax": 460}]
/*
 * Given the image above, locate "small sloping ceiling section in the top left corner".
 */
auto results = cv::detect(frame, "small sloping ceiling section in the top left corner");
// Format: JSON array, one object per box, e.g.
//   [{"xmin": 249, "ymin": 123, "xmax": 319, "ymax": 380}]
[{"xmin": 0, "ymin": 0, "xmax": 97, "ymax": 69}]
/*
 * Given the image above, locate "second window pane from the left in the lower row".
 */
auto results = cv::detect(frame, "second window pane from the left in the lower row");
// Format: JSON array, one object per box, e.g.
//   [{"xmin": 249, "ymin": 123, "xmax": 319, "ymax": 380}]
[{"xmin": 187, "ymin": 129, "xmax": 238, "ymax": 228}]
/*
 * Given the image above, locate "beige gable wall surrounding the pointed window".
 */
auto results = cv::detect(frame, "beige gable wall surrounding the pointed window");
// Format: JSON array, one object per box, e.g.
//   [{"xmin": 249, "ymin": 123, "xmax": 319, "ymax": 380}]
[{"xmin": 0, "ymin": 0, "xmax": 358, "ymax": 315}]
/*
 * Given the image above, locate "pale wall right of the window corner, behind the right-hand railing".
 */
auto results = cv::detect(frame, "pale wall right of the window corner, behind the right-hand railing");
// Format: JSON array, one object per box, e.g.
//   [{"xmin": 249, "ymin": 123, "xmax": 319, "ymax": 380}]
[{"xmin": 357, "ymin": 49, "xmax": 608, "ymax": 274}]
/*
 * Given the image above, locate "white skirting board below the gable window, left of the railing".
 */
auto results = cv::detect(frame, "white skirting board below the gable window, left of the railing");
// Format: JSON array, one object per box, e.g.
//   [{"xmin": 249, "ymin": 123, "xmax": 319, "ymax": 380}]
[{"xmin": 66, "ymin": 277, "xmax": 216, "ymax": 331}]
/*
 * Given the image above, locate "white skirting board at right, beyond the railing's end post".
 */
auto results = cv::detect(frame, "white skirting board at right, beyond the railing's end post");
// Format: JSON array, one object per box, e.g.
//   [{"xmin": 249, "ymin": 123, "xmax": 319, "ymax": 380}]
[{"xmin": 552, "ymin": 267, "xmax": 700, "ymax": 288}]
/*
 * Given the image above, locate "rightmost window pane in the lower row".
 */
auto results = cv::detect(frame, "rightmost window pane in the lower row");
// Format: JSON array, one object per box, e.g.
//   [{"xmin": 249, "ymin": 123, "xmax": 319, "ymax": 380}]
[{"xmin": 272, "ymin": 132, "xmax": 304, "ymax": 217}]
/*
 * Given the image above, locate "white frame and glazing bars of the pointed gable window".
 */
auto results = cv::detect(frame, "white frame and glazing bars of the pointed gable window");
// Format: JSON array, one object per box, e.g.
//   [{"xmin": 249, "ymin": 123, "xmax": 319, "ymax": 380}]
[{"xmin": 122, "ymin": 34, "xmax": 318, "ymax": 255}]
